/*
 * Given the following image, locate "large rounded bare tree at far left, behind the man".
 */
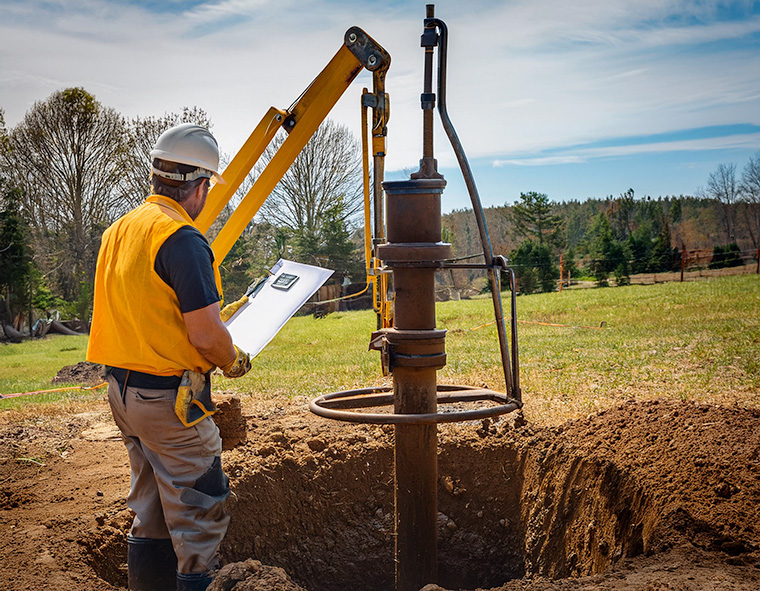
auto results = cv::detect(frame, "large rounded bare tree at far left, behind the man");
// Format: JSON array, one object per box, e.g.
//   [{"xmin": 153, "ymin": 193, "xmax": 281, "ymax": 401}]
[{"xmin": 3, "ymin": 88, "xmax": 128, "ymax": 310}]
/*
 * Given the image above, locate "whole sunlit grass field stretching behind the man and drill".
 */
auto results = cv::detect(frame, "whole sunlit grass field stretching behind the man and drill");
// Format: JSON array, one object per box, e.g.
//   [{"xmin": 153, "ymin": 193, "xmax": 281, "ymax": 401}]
[{"xmin": 0, "ymin": 275, "xmax": 760, "ymax": 424}]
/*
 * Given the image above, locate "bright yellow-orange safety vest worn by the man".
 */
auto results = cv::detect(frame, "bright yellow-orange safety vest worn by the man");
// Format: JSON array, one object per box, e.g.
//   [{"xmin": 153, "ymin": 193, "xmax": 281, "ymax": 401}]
[{"xmin": 87, "ymin": 195, "xmax": 222, "ymax": 376}]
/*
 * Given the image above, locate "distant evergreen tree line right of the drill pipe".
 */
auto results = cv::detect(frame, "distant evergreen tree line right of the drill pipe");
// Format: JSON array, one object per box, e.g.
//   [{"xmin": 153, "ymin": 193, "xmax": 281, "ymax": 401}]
[{"xmin": 444, "ymin": 152, "xmax": 760, "ymax": 293}]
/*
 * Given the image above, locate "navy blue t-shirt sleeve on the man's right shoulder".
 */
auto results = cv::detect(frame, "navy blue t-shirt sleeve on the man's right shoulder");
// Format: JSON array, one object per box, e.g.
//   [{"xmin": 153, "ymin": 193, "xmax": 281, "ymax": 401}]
[{"xmin": 154, "ymin": 226, "xmax": 222, "ymax": 314}]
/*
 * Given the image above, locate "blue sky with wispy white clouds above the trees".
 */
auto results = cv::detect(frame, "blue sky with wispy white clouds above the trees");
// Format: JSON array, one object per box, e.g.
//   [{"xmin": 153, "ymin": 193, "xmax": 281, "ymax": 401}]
[{"xmin": 0, "ymin": 0, "xmax": 760, "ymax": 211}]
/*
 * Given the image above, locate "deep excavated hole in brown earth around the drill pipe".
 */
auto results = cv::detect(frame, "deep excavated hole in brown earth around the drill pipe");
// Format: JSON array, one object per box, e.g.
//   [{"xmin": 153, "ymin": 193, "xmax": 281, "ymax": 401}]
[{"xmin": 81, "ymin": 430, "xmax": 657, "ymax": 591}]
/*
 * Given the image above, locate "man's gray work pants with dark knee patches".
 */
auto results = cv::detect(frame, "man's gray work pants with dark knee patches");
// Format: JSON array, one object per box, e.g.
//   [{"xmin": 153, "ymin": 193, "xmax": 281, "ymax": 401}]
[{"xmin": 108, "ymin": 376, "xmax": 230, "ymax": 574}]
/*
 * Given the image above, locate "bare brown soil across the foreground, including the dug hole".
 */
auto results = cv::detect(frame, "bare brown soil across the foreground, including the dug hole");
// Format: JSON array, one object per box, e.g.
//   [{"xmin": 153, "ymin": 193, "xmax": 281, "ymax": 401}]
[{"xmin": 0, "ymin": 398, "xmax": 760, "ymax": 591}]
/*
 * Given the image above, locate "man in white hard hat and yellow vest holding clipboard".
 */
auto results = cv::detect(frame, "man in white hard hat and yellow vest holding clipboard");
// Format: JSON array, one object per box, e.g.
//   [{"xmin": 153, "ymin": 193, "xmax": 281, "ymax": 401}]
[{"xmin": 87, "ymin": 123, "xmax": 251, "ymax": 591}]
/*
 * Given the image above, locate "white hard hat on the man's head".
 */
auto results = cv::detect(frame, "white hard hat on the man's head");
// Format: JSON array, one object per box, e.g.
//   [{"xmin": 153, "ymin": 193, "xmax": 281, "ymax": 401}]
[{"xmin": 150, "ymin": 123, "xmax": 224, "ymax": 183}]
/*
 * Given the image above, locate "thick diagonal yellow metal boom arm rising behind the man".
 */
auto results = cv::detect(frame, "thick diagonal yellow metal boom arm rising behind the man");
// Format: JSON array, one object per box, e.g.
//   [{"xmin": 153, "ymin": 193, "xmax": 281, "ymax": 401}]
[{"xmin": 203, "ymin": 27, "xmax": 390, "ymax": 261}]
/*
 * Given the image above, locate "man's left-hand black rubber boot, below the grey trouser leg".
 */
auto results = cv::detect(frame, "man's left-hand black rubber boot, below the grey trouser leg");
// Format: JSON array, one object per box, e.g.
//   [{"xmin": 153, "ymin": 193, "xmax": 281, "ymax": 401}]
[{"xmin": 127, "ymin": 536, "xmax": 177, "ymax": 591}]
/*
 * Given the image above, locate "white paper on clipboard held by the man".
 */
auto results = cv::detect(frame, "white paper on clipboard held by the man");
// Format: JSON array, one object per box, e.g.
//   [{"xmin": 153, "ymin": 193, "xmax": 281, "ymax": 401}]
[{"xmin": 225, "ymin": 259, "xmax": 333, "ymax": 357}]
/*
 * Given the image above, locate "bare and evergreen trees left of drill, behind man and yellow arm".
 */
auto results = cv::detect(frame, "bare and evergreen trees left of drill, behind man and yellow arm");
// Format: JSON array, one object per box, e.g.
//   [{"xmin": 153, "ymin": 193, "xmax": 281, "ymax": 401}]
[{"xmin": 0, "ymin": 88, "xmax": 363, "ymax": 327}]
